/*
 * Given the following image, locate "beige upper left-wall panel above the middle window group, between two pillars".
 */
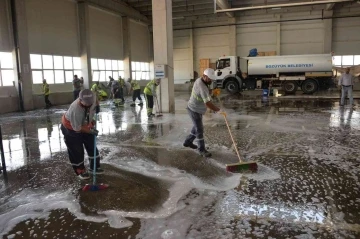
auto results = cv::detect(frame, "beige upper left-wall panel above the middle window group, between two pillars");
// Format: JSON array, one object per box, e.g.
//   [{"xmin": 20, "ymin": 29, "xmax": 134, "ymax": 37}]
[{"xmin": 89, "ymin": 7, "xmax": 124, "ymax": 60}]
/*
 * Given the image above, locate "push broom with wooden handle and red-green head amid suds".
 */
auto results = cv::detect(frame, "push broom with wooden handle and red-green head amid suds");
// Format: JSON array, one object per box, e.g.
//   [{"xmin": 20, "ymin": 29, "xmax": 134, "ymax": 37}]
[{"xmin": 222, "ymin": 113, "xmax": 257, "ymax": 173}]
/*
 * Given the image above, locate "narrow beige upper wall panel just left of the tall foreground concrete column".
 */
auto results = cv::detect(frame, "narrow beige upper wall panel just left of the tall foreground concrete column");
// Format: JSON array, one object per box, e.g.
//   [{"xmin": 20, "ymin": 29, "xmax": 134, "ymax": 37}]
[{"xmin": 129, "ymin": 20, "xmax": 150, "ymax": 62}]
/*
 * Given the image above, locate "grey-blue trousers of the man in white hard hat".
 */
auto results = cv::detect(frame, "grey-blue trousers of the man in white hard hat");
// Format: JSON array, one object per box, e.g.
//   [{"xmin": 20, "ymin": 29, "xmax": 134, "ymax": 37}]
[{"xmin": 185, "ymin": 108, "xmax": 205, "ymax": 152}]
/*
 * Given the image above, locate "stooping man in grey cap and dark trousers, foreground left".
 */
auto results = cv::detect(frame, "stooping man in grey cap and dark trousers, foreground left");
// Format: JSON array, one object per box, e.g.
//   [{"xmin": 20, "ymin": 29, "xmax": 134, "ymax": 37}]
[{"xmin": 61, "ymin": 89, "xmax": 104, "ymax": 180}]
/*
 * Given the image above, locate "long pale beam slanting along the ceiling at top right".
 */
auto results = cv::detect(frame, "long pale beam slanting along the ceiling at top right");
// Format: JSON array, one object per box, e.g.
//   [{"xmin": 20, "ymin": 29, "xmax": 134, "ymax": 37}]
[{"xmin": 216, "ymin": 0, "xmax": 353, "ymax": 12}]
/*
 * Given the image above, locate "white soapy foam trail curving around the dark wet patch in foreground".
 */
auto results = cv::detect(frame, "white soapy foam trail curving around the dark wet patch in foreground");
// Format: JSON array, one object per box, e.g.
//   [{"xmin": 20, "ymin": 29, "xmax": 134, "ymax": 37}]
[{"xmin": 0, "ymin": 141, "xmax": 248, "ymax": 236}]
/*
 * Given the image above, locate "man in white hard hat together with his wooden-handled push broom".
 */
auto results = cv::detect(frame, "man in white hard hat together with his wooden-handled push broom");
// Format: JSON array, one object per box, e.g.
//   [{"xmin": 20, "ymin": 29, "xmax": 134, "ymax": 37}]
[{"xmin": 183, "ymin": 68, "xmax": 257, "ymax": 172}]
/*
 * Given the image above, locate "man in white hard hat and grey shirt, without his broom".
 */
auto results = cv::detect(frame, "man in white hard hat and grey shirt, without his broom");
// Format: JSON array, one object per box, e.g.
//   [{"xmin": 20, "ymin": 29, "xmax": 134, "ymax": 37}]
[{"xmin": 183, "ymin": 68, "xmax": 221, "ymax": 157}]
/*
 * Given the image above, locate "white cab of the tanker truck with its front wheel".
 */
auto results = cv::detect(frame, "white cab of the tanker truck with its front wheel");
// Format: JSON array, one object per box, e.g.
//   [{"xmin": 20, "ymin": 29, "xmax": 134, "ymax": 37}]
[{"xmin": 214, "ymin": 56, "xmax": 243, "ymax": 93}]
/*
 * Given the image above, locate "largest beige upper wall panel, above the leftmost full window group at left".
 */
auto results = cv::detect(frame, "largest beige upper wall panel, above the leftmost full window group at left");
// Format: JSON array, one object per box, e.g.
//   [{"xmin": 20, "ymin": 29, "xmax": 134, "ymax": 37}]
[{"xmin": 25, "ymin": 0, "xmax": 79, "ymax": 56}]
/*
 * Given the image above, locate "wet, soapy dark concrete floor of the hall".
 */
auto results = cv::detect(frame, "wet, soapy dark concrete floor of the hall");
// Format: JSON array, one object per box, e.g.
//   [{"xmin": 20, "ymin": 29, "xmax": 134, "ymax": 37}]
[{"xmin": 0, "ymin": 93, "xmax": 360, "ymax": 239}]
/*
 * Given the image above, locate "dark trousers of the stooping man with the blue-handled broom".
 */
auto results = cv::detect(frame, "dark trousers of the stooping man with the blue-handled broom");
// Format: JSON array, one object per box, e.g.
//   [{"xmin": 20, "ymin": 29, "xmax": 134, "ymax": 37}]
[{"xmin": 61, "ymin": 125, "xmax": 100, "ymax": 175}]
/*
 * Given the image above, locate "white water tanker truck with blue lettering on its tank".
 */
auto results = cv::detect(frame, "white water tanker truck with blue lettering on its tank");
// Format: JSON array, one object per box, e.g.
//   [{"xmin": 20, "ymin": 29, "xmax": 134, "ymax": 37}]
[{"xmin": 214, "ymin": 54, "xmax": 333, "ymax": 94}]
